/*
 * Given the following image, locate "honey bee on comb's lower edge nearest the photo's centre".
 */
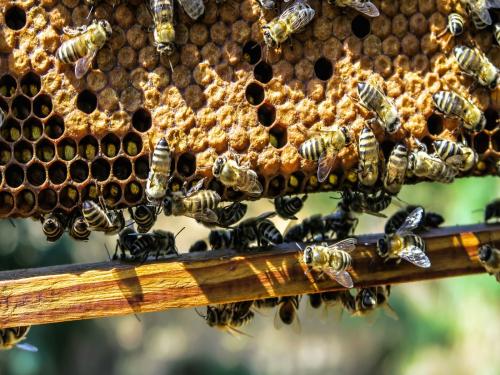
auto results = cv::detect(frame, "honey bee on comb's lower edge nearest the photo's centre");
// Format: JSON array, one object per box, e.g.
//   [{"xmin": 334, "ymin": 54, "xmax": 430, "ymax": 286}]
[{"xmin": 212, "ymin": 156, "xmax": 264, "ymax": 196}]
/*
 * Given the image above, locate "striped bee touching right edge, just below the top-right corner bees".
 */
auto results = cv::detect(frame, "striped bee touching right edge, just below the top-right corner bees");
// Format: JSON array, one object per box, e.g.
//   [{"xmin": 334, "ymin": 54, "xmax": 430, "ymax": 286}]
[{"xmin": 453, "ymin": 46, "xmax": 500, "ymax": 90}]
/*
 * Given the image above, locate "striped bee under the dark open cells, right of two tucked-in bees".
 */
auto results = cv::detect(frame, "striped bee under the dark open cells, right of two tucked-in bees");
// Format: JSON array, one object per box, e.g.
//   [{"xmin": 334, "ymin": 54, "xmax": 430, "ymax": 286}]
[{"xmin": 82, "ymin": 200, "xmax": 125, "ymax": 235}]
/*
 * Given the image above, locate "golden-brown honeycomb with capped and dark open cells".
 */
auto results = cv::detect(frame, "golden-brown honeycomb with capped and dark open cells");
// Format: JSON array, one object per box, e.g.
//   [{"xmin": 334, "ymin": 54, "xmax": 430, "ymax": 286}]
[{"xmin": 0, "ymin": 0, "xmax": 500, "ymax": 217}]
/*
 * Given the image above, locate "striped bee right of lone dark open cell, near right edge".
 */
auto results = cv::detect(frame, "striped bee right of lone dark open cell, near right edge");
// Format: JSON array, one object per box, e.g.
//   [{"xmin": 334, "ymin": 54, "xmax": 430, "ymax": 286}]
[{"xmin": 432, "ymin": 91, "xmax": 486, "ymax": 132}]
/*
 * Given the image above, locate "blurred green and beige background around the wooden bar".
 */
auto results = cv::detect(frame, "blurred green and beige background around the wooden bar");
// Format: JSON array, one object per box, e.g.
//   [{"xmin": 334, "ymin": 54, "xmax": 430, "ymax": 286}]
[{"xmin": 0, "ymin": 177, "xmax": 500, "ymax": 375}]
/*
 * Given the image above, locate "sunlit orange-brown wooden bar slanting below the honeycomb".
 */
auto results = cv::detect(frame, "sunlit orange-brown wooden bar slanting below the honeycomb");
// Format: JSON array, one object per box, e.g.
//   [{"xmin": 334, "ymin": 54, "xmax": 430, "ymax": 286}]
[{"xmin": 0, "ymin": 224, "xmax": 500, "ymax": 328}]
